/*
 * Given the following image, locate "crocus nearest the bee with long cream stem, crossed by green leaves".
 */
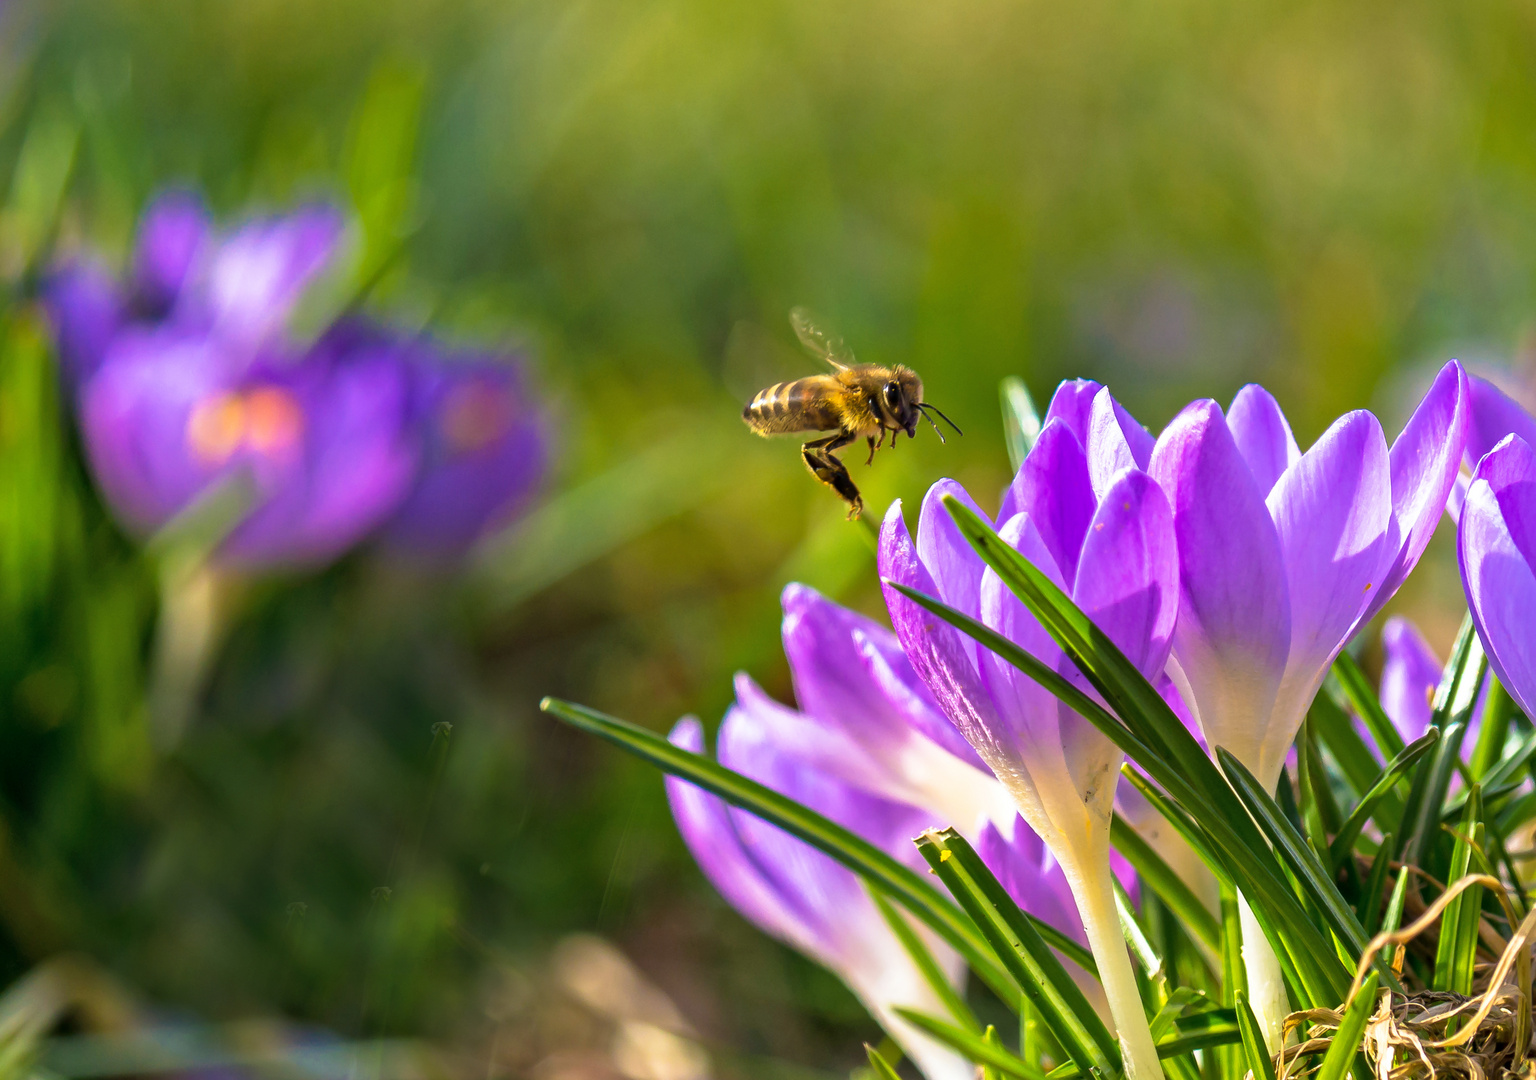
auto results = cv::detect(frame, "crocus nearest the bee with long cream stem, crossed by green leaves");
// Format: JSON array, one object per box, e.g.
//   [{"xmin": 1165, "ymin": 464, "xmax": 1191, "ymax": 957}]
[{"xmin": 879, "ymin": 383, "xmax": 1178, "ymax": 1078}]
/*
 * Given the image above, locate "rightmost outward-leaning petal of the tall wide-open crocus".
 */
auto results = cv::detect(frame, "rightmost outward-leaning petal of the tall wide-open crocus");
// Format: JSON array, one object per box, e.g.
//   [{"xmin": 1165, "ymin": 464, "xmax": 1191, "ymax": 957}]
[{"xmin": 1355, "ymin": 359, "xmax": 1468, "ymax": 630}]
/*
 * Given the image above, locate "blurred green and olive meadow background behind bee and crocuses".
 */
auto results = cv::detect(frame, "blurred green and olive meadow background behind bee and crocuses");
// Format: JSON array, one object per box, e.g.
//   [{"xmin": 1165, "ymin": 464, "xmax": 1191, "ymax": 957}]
[{"xmin": 0, "ymin": 0, "xmax": 1536, "ymax": 1080}]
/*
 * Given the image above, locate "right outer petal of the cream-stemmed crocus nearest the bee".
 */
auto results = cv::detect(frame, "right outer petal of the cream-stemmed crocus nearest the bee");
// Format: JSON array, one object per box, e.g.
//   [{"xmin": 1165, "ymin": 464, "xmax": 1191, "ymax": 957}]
[{"xmin": 1072, "ymin": 469, "xmax": 1178, "ymax": 679}]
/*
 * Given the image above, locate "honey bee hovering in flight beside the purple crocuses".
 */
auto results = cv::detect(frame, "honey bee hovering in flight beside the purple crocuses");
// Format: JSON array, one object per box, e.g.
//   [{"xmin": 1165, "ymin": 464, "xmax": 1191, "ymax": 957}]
[{"xmin": 742, "ymin": 307, "xmax": 963, "ymax": 521}]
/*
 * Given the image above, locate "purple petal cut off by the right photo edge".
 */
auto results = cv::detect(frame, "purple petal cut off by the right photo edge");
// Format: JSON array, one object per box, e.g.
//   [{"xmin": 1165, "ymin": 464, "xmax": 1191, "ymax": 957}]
[{"xmin": 1458, "ymin": 435, "xmax": 1536, "ymax": 716}]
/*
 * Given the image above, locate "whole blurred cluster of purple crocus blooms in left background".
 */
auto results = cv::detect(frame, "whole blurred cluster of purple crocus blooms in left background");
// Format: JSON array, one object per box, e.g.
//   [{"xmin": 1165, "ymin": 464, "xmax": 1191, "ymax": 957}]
[{"xmin": 45, "ymin": 192, "xmax": 547, "ymax": 571}]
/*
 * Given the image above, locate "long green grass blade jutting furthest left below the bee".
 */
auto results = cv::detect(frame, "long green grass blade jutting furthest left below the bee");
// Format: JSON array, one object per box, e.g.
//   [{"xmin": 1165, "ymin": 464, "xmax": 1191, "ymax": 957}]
[{"xmin": 539, "ymin": 697, "xmax": 1018, "ymax": 1002}]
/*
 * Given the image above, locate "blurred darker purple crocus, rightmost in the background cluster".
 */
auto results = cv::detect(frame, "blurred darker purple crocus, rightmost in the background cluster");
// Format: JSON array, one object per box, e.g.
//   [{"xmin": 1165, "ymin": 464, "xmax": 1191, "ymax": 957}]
[{"xmin": 386, "ymin": 341, "xmax": 548, "ymax": 556}]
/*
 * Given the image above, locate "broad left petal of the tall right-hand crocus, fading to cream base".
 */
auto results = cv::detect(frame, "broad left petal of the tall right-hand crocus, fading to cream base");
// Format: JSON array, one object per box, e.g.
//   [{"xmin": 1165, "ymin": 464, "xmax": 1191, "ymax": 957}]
[{"xmin": 1152, "ymin": 401, "xmax": 1290, "ymax": 765}]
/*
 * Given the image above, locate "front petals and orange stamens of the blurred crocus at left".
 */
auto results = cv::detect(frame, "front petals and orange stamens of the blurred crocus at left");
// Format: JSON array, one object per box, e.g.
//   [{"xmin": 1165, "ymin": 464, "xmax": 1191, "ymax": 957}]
[{"xmin": 80, "ymin": 327, "xmax": 415, "ymax": 567}]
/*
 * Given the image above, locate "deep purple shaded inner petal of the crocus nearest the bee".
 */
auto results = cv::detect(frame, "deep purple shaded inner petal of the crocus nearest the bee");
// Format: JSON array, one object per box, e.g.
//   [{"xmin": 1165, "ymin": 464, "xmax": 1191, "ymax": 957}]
[{"xmin": 1001, "ymin": 419, "xmax": 1094, "ymax": 581}]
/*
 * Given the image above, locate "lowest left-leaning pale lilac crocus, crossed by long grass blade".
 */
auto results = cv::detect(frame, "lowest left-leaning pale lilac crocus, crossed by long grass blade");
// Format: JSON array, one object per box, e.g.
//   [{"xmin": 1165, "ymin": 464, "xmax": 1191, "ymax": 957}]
[{"xmin": 667, "ymin": 701, "xmax": 972, "ymax": 1080}]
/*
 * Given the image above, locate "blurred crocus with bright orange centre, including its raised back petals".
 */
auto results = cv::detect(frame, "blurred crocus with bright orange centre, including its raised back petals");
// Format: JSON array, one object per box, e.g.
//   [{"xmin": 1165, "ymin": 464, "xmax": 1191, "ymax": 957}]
[{"xmin": 46, "ymin": 194, "xmax": 418, "ymax": 568}]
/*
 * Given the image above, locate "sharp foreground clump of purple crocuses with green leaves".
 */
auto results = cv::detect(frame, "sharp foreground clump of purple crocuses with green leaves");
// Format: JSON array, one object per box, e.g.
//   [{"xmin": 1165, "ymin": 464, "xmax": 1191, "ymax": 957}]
[{"xmin": 545, "ymin": 354, "xmax": 1536, "ymax": 1077}]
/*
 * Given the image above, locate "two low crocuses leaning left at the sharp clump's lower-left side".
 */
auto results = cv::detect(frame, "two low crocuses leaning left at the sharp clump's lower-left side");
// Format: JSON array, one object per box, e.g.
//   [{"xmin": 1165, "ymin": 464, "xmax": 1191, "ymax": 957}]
[{"xmin": 667, "ymin": 585, "xmax": 1134, "ymax": 1080}]
